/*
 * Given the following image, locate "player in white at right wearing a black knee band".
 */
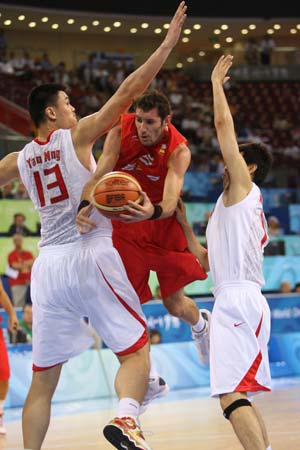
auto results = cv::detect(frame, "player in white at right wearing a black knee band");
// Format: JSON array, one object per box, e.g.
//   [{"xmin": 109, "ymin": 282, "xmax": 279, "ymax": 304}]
[{"xmin": 177, "ymin": 55, "xmax": 272, "ymax": 450}]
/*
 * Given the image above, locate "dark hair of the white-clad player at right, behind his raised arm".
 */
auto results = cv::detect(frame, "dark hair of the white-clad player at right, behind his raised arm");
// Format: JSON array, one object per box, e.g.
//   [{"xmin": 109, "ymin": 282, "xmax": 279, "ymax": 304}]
[{"xmin": 239, "ymin": 142, "xmax": 273, "ymax": 185}]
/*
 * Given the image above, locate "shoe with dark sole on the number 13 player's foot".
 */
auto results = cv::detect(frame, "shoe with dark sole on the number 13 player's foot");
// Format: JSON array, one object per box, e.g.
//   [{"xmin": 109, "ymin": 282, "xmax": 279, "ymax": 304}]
[{"xmin": 103, "ymin": 417, "xmax": 152, "ymax": 450}]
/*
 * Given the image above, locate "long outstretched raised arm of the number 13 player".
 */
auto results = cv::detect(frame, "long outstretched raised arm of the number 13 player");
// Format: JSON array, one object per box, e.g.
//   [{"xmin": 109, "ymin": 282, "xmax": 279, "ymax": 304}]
[{"xmin": 72, "ymin": 2, "xmax": 186, "ymax": 154}]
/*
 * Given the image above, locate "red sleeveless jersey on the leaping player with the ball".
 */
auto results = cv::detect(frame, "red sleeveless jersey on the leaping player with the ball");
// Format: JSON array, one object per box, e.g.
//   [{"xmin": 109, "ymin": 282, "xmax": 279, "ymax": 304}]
[{"xmin": 114, "ymin": 113, "xmax": 187, "ymax": 203}]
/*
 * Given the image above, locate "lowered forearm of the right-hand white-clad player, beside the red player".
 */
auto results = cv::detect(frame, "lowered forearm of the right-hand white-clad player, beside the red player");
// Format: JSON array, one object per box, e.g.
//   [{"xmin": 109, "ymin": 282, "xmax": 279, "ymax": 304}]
[{"xmin": 176, "ymin": 199, "xmax": 209, "ymax": 272}]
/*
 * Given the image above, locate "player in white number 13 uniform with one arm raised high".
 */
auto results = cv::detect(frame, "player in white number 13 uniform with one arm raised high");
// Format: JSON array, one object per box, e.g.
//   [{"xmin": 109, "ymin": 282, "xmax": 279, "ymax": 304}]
[{"xmin": 0, "ymin": 2, "xmax": 186, "ymax": 450}]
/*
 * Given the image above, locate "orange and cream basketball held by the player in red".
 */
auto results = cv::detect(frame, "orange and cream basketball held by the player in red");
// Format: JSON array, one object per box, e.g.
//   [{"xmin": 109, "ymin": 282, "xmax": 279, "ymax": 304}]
[{"xmin": 92, "ymin": 171, "xmax": 142, "ymax": 219}]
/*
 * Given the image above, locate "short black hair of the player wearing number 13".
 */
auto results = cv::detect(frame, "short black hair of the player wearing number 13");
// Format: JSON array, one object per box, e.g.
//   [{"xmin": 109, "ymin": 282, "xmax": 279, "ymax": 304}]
[{"xmin": 28, "ymin": 83, "xmax": 66, "ymax": 127}]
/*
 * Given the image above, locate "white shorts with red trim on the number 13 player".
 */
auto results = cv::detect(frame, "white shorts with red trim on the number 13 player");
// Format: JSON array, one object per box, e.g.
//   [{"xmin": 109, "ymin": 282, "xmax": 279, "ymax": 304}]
[{"xmin": 31, "ymin": 236, "xmax": 147, "ymax": 370}]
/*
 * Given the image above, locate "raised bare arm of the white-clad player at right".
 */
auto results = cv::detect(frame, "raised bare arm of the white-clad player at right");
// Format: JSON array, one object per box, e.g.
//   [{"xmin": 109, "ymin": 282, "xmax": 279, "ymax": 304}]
[{"xmin": 211, "ymin": 55, "xmax": 252, "ymax": 199}]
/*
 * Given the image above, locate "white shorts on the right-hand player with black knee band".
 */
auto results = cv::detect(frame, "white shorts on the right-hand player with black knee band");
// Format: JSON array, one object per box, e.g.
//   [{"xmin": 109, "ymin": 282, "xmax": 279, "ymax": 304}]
[{"xmin": 210, "ymin": 281, "xmax": 271, "ymax": 397}]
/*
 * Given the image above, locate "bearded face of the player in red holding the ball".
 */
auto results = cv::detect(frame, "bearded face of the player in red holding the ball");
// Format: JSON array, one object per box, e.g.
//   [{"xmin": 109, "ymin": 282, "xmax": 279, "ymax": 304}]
[{"xmin": 135, "ymin": 108, "xmax": 167, "ymax": 147}]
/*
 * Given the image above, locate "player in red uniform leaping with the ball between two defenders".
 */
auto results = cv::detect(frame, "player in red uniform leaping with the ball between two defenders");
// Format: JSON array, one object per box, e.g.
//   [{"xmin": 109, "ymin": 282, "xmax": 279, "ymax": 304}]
[{"xmin": 77, "ymin": 91, "xmax": 210, "ymax": 364}]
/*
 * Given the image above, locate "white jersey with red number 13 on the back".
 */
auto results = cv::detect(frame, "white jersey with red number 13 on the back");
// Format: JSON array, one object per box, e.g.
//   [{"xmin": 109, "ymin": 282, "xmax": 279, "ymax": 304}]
[{"xmin": 18, "ymin": 129, "xmax": 112, "ymax": 247}]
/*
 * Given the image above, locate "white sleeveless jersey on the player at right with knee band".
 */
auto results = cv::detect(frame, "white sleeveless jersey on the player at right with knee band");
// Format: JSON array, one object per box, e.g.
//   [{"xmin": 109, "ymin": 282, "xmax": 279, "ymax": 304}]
[{"xmin": 206, "ymin": 183, "xmax": 268, "ymax": 287}]
